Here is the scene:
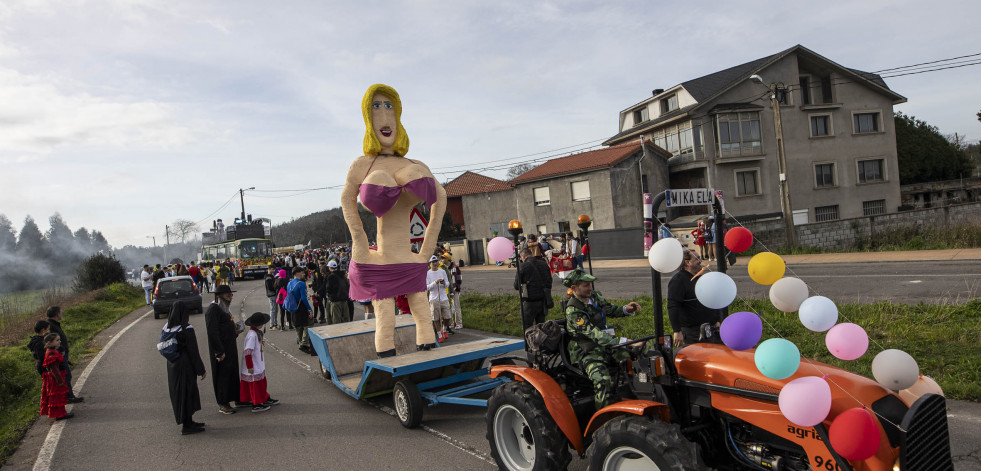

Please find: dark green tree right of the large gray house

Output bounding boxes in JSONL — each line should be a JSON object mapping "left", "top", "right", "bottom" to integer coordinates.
{"left": 895, "top": 113, "right": 972, "bottom": 185}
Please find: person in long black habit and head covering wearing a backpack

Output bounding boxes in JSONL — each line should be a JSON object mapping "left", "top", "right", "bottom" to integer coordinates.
{"left": 164, "top": 301, "right": 207, "bottom": 435}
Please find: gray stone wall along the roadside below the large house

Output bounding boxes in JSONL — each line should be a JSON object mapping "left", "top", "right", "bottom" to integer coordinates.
{"left": 744, "top": 203, "right": 981, "bottom": 250}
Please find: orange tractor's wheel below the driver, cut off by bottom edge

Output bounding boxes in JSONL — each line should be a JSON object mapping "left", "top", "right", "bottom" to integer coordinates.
{"left": 587, "top": 415, "right": 707, "bottom": 471}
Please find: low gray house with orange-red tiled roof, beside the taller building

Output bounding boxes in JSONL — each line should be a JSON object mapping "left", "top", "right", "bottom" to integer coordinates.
{"left": 510, "top": 138, "right": 671, "bottom": 234}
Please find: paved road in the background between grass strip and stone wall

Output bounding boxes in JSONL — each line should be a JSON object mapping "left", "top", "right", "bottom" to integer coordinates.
{"left": 463, "top": 260, "right": 981, "bottom": 304}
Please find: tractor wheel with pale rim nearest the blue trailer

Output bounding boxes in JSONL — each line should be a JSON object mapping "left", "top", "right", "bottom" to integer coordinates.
{"left": 486, "top": 381, "right": 572, "bottom": 471}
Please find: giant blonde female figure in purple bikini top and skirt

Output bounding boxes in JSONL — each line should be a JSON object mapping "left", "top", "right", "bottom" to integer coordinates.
{"left": 341, "top": 84, "right": 446, "bottom": 357}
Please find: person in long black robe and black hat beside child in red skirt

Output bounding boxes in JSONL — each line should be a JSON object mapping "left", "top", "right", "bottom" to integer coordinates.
{"left": 204, "top": 285, "right": 244, "bottom": 414}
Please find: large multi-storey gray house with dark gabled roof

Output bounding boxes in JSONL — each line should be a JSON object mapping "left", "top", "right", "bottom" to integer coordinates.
{"left": 608, "top": 45, "right": 906, "bottom": 227}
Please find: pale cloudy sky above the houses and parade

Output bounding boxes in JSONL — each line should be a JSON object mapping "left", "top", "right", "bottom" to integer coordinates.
{"left": 0, "top": 0, "right": 981, "bottom": 247}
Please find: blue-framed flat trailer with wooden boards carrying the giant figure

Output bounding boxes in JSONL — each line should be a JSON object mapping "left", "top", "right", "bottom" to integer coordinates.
{"left": 309, "top": 315, "right": 524, "bottom": 428}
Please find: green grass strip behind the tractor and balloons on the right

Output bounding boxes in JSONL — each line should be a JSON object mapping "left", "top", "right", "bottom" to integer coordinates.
{"left": 462, "top": 293, "right": 981, "bottom": 402}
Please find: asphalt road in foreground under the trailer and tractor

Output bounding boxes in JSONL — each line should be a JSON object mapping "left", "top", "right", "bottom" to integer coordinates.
{"left": 5, "top": 276, "right": 981, "bottom": 471}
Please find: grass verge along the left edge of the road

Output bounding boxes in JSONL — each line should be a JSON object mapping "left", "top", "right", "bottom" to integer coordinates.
{"left": 0, "top": 283, "right": 145, "bottom": 463}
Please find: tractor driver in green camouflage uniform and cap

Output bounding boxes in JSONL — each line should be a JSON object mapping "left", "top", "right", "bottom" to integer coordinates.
{"left": 562, "top": 268, "right": 640, "bottom": 410}
